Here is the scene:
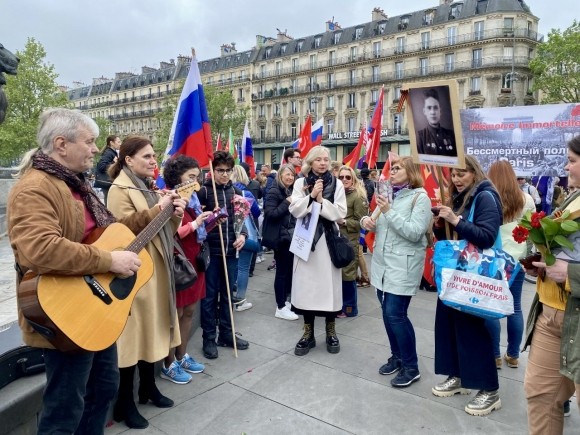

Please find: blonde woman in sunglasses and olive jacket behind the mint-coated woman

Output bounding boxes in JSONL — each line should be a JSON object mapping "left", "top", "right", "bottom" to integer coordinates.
{"left": 337, "top": 166, "right": 369, "bottom": 318}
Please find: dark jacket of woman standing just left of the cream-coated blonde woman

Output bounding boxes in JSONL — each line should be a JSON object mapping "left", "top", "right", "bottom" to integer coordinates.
{"left": 262, "top": 183, "right": 296, "bottom": 249}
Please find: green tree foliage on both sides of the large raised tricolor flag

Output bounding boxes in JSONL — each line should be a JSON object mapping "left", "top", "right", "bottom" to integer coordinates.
{"left": 154, "top": 82, "right": 249, "bottom": 164}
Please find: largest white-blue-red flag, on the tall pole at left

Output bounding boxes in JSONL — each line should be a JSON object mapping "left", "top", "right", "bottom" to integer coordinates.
{"left": 157, "top": 54, "right": 213, "bottom": 187}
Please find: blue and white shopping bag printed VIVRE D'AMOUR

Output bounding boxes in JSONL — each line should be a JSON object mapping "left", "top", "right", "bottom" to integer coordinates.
{"left": 433, "top": 192, "right": 520, "bottom": 319}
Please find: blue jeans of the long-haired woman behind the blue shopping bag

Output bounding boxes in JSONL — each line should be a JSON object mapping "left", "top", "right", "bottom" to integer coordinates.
{"left": 486, "top": 270, "right": 525, "bottom": 358}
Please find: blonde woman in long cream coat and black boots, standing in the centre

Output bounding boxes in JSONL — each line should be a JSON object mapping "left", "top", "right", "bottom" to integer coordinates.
{"left": 290, "top": 146, "right": 346, "bottom": 356}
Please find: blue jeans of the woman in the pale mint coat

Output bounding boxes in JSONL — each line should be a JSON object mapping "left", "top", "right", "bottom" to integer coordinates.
{"left": 377, "top": 289, "right": 419, "bottom": 370}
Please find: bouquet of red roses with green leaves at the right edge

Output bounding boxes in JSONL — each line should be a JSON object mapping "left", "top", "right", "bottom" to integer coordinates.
{"left": 512, "top": 210, "right": 580, "bottom": 266}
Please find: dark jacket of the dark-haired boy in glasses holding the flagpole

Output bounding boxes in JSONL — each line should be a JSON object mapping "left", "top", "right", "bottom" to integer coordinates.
{"left": 197, "top": 180, "right": 247, "bottom": 256}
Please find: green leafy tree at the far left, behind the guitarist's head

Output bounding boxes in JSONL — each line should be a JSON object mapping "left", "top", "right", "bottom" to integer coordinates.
{"left": 0, "top": 38, "right": 69, "bottom": 160}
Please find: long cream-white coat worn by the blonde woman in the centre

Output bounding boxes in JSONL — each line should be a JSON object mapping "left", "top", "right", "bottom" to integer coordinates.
{"left": 290, "top": 178, "right": 346, "bottom": 312}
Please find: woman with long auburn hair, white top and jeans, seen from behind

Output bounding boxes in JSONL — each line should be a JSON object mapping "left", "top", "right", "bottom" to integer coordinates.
{"left": 487, "top": 160, "right": 536, "bottom": 369}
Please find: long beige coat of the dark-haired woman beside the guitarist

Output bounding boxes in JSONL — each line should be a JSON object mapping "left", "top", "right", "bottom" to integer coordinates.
{"left": 107, "top": 172, "right": 180, "bottom": 367}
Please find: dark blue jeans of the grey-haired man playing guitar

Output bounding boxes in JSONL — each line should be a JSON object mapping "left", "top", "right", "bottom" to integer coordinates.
{"left": 38, "top": 344, "right": 119, "bottom": 434}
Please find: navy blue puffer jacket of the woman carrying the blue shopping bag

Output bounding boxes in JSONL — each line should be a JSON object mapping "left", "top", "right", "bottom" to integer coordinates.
{"left": 433, "top": 180, "right": 503, "bottom": 249}
